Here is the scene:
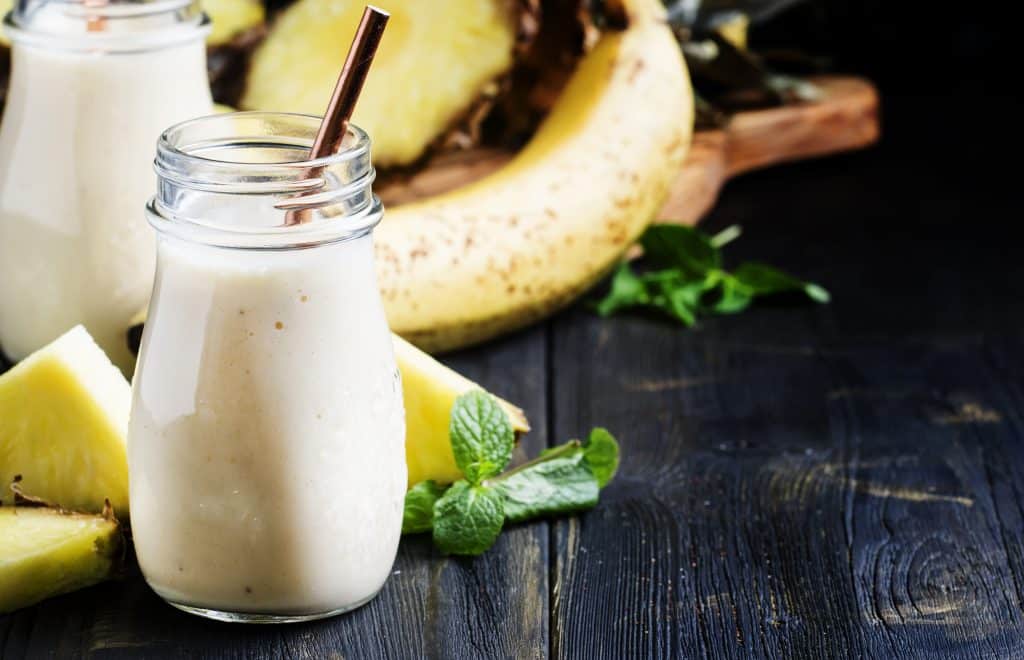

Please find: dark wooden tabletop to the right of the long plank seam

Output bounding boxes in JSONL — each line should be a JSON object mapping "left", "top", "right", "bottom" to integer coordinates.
{"left": 550, "top": 117, "right": 1024, "bottom": 658}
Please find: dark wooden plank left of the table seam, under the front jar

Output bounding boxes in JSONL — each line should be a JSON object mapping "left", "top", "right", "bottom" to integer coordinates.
{"left": 0, "top": 327, "right": 549, "bottom": 660}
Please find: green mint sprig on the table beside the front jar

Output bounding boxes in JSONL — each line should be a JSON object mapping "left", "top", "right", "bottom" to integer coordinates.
{"left": 401, "top": 391, "right": 618, "bottom": 555}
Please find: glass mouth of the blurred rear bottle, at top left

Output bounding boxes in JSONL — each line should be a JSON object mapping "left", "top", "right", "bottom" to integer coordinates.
{"left": 3, "top": 0, "right": 210, "bottom": 53}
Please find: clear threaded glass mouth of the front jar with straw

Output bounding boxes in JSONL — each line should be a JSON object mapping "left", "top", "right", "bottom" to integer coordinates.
{"left": 146, "top": 112, "right": 383, "bottom": 250}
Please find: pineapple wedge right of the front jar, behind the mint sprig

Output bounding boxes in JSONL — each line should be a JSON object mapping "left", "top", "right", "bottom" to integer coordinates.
{"left": 392, "top": 335, "right": 529, "bottom": 486}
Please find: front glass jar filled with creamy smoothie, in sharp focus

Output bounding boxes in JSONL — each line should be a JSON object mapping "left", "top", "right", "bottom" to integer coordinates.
{"left": 128, "top": 113, "right": 407, "bottom": 621}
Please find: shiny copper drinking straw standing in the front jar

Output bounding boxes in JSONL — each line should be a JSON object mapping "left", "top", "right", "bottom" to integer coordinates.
{"left": 285, "top": 5, "right": 390, "bottom": 225}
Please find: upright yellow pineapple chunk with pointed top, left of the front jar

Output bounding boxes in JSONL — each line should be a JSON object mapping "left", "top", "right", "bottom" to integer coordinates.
{"left": 0, "top": 325, "right": 131, "bottom": 516}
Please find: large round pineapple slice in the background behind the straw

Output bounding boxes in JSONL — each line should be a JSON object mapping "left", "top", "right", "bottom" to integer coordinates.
{"left": 242, "top": 0, "right": 520, "bottom": 167}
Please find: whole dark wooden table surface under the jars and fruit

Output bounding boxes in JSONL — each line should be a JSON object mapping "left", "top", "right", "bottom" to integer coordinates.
{"left": 0, "top": 86, "right": 1024, "bottom": 660}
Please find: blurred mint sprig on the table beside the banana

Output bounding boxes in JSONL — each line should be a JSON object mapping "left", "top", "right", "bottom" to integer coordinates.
{"left": 596, "top": 224, "right": 830, "bottom": 326}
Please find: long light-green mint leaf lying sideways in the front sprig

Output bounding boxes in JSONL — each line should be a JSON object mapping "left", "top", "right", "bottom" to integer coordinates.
{"left": 495, "top": 450, "right": 600, "bottom": 523}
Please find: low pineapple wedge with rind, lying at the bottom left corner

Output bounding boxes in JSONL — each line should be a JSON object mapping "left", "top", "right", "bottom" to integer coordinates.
{"left": 0, "top": 507, "right": 121, "bottom": 613}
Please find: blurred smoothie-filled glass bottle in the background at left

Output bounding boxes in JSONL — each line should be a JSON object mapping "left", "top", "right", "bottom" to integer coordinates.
{"left": 0, "top": 0, "right": 212, "bottom": 373}
